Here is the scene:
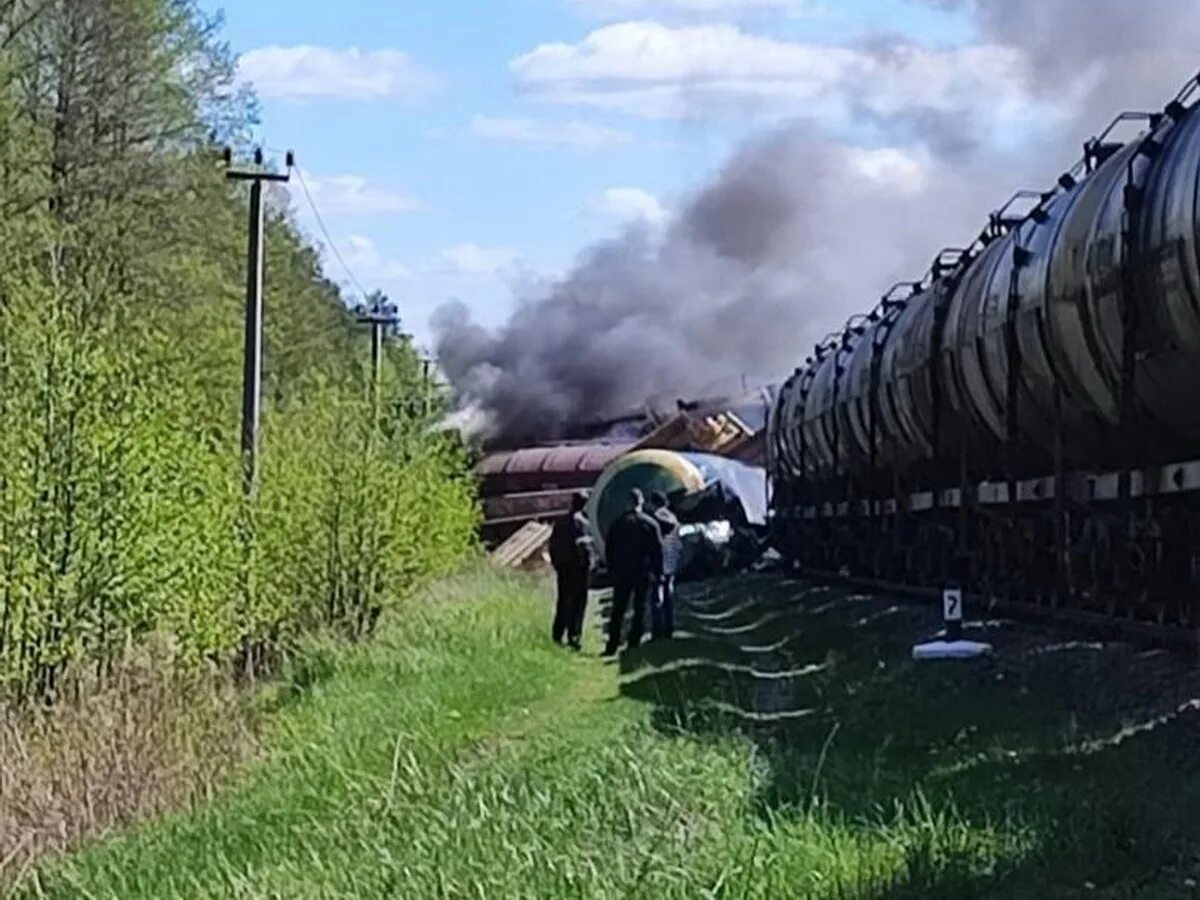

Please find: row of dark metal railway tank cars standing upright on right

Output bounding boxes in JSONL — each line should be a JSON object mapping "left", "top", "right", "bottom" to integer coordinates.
{"left": 767, "top": 79, "right": 1200, "bottom": 628}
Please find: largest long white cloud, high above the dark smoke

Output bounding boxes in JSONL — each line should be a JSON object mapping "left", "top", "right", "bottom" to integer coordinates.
{"left": 509, "top": 22, "right": 1033, "bottom": 120}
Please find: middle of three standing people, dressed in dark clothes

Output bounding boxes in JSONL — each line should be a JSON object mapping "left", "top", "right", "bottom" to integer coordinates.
{"left": 604, "top": 487, "right": 662, "bottom": 656}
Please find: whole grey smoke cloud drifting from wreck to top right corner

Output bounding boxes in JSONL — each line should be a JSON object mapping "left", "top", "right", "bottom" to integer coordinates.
{"left": 433, "top": 0, "right": 1200, "bottom": 444}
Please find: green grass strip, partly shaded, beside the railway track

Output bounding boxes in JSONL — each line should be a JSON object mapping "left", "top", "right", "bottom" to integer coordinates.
{"left": 17, "top": 575, "right": 1200, "bottom": 900}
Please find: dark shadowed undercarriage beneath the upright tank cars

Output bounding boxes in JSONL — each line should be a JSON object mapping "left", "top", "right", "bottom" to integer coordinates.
{"left": 772, "top": 461, "right": 1200, "bottom": 638}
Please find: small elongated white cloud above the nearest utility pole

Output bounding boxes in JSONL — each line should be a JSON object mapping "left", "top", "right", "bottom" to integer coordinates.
{"left": 238, "top": 44, "right": 437, "bottom": 100}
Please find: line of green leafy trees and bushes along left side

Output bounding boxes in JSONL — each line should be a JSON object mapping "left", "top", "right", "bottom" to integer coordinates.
{"left": 0, "top": 0, "right": 476, "bottom": 702}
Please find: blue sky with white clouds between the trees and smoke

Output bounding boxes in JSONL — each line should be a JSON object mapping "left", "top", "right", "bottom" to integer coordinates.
{"left": 203, "top": 0, "right": 995, "bottom": 350}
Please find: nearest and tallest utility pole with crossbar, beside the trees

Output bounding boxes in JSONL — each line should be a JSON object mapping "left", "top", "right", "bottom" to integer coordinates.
{"left": 224, "top": 148, "right": 295, "bottom": 497}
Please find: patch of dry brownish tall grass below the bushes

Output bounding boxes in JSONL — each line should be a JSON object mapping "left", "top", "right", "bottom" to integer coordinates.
{"left": 0, "top": 641, "right": 257, "bottom": 882}
